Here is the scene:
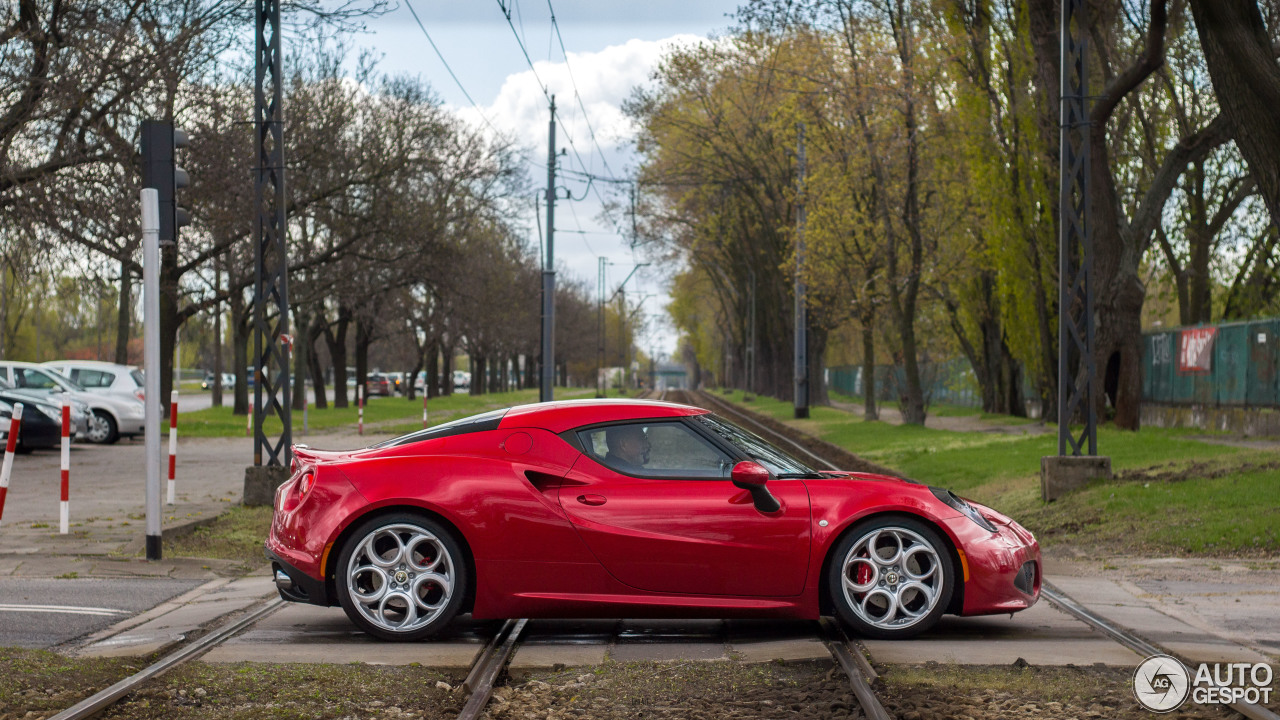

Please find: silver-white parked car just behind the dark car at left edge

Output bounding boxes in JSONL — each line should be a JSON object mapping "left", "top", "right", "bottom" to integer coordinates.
{"left": 0, "top": 360, "right": 124, "bottom": 443}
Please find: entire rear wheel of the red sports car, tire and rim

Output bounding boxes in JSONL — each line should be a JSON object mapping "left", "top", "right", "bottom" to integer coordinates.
{"left": 337, "top": 514, "right": 467, "bottom": 641}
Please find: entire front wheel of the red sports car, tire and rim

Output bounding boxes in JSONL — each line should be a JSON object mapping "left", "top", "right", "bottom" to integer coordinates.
{"left": 827, "top": 518, "right": 955, "bottom": 639}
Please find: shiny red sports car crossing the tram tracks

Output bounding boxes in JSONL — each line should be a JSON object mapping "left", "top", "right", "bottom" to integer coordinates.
{"left": 266, "top": 400, "right": 1041, "bottom": 641}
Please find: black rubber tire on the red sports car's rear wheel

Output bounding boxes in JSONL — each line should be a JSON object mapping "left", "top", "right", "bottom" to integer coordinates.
{"left": 334, "top": 512, "right": 471, "bottom": 642}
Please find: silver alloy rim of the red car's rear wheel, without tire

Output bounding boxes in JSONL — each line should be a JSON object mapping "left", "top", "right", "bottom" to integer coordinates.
{"left": 346, "top": 523, "right": 456, "bottom": 633}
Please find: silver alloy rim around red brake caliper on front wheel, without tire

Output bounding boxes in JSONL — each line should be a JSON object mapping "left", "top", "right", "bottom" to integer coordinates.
{"left": 840, "top": 527, "right": 946, "bottom": 630}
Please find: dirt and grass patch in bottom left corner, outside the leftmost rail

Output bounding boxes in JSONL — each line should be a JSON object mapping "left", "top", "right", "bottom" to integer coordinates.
{"left": 0, "top": 647, "right": 141, "bottom": 720}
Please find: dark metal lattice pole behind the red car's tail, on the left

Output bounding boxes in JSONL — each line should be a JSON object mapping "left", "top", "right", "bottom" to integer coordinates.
{"left": 253, "top": 0, "right": 292, "bottom": 466}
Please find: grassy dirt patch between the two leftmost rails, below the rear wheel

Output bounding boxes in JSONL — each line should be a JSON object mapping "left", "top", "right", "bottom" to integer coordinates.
{"left": 102, "top": 662, "right": 466, "bottom": 720}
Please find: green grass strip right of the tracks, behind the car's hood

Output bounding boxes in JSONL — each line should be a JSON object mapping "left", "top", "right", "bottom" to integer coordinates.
{"left": 727, "top": 393, "right": 1280, "bottom": 555}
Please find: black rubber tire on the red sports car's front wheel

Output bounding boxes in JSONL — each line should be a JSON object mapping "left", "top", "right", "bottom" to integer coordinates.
{"left": 827, "top": 515, "right": 956, "bottom": 639}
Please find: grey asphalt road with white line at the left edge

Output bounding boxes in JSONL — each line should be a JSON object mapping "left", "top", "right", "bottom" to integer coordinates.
{"left": 0, "top": 577, "right": 202, "bottom": 647}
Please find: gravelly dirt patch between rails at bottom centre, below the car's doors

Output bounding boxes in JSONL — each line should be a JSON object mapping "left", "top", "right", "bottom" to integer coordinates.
{"left": 489, "top": 661, "right": 863, "bottom": 720}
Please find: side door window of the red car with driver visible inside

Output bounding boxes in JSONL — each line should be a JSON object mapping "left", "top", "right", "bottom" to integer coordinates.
{"left": 579, "top": 421, "right": 733, "bottom": 479}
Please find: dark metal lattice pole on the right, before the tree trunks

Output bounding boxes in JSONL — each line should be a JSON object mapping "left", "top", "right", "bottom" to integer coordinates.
{"left": 1057, "top": 0, "right": 1098, "bottom": 455}
